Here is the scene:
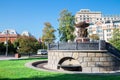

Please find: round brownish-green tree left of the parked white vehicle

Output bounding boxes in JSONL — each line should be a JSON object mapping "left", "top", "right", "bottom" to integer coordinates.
{"left": 14, "top": 36, "right": 39, "bottom": 54}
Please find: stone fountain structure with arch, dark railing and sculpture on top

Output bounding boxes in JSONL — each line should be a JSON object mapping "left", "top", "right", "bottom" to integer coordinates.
{"left": 29, "top": 22, "right": 120, "bottom": 73}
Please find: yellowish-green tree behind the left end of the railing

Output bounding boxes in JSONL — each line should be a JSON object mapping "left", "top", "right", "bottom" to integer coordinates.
{"left": 42, "top": 22, "right": 55, "bottom": 43}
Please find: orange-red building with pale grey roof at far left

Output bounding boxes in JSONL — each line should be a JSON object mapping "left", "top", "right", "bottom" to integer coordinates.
{"left": 0, "top": 29, "right": 18, "bottom": 43}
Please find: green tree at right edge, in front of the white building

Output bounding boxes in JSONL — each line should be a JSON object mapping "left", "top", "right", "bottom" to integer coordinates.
{"left": 109, "top": 28, "right": 120, "bottom": 50}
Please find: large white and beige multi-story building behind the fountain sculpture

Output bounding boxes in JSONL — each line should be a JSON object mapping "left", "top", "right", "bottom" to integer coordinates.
{"left": 75, "top": 9, "right": 120, "bottom": 41}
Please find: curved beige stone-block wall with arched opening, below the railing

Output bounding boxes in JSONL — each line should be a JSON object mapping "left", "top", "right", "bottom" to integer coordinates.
{"left": 48, "top": 50, "right": 120, "bottom": 73}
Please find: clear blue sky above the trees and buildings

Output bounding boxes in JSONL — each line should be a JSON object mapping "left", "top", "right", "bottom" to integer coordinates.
{"left": 0, "top": 0, "right": 120, "bottom": 39}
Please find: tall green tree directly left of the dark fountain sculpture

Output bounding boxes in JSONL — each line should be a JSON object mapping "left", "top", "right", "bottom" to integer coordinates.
{"left": 58, "top": 9, "right": 75, "bottom": 42}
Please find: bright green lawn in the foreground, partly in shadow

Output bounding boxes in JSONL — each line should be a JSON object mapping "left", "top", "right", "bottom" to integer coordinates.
{"left": 0, "top": 58, "right": 120, "bottom": 80}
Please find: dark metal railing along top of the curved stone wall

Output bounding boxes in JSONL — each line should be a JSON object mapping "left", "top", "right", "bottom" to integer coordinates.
{"left": 48, "top": 40, "right": 106, "bottom": 50}
